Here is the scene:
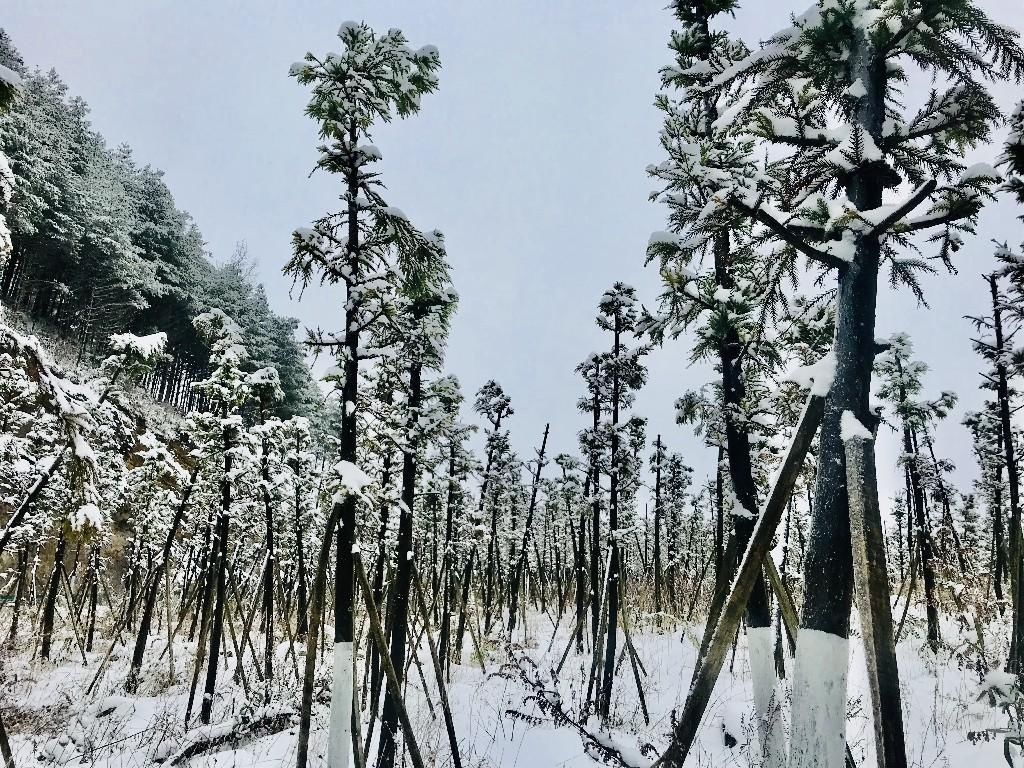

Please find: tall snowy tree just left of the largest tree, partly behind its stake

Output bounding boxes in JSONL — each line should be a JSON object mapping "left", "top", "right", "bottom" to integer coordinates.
{"left": 648, "top": 2, "right": 792, "bottom": 766}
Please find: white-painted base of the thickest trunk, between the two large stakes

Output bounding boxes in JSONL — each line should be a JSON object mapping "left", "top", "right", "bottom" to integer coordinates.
{"left": 790, "top": 629, "right": 850, "bottom": 768}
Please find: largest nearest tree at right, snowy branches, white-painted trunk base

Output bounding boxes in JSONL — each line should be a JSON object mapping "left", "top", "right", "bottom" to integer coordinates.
{"left": 719, "top": 0, "right": 1024, "bottom": 768}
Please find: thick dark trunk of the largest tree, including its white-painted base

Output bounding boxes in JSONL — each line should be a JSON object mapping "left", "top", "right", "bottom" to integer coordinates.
{"left": 790, "top": 30, "right": 887, "bottom": 768}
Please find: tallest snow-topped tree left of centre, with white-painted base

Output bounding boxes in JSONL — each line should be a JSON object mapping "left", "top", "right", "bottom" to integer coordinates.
{"left": 285, "top": 22, "right": 440, "bottom": 768}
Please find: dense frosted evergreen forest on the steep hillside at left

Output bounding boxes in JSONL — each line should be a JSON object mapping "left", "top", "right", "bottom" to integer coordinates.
{"left": 0, "top": 30, "right": 319, "bottom": 415}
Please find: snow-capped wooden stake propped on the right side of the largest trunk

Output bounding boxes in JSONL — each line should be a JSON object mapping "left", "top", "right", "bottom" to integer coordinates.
{"left": 843, "top": 428, "right": 906, "bottom": 768}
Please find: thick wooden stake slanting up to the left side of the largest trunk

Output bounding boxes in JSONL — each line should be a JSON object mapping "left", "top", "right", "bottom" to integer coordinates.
{"left": 655, "top": 394, "right": 824, "bottom": 768}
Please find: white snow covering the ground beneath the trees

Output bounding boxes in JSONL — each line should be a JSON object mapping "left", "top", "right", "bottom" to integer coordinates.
{"left": 0, "top": 615, "right": 1006, "bottom": 768}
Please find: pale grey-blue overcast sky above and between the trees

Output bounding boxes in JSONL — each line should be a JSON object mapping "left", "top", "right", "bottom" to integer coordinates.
{"left": 0, "top": 0, "right": 1024, "bottom": 507}
